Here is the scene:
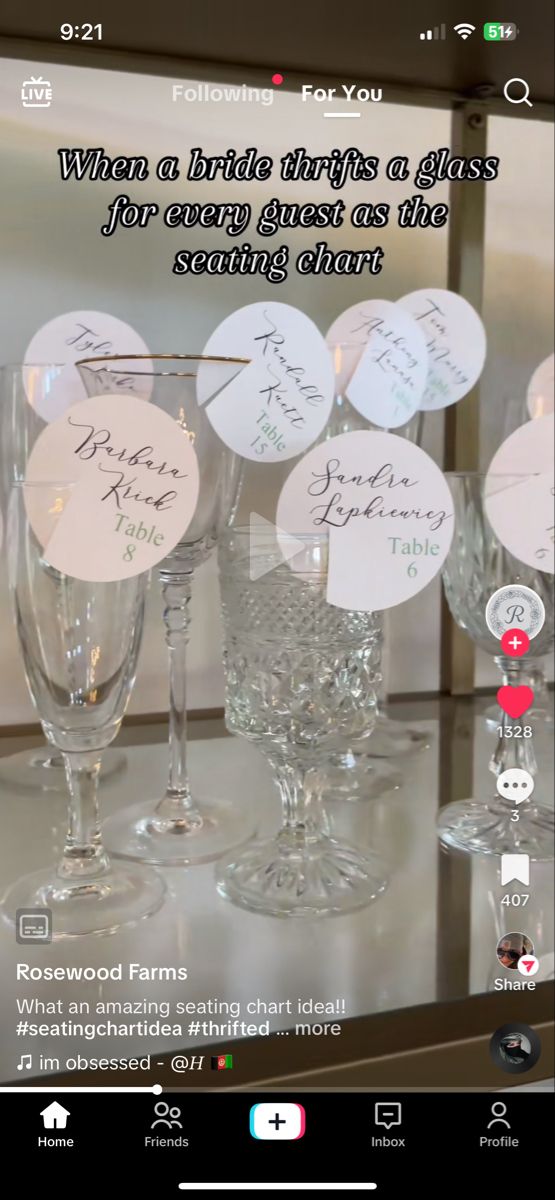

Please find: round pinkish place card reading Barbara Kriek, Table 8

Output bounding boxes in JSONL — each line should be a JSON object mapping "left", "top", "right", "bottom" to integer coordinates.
{"left": 25, "top": 394, "right": 198, "bottom": 582}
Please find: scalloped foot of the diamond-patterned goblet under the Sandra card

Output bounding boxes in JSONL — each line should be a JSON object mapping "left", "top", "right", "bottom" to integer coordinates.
{"left": 216, "top": 833, "right": 388, "bottom": 917}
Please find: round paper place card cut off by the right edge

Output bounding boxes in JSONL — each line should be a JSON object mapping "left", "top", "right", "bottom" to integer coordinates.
{"left": 485, "top": 413, "right": 555, "bottom": 574}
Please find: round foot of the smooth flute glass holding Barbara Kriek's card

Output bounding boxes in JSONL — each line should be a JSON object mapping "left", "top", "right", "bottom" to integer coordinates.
{"left": 2, "top": 863, "right": 166, "bottom": 941}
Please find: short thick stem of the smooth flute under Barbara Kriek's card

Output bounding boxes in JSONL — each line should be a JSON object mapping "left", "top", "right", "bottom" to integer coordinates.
{"left": 58, "top": 750, "right": 109, "bottom": 880}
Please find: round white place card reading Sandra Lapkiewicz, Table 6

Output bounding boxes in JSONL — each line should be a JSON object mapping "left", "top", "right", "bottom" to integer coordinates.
{"left": 276, "top": 430, "right": 454, "bottom": 611}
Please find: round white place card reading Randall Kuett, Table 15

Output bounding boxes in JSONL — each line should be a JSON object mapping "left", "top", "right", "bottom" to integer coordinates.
{"left": 197, "top": 301, "right": 334, "bottom": 462}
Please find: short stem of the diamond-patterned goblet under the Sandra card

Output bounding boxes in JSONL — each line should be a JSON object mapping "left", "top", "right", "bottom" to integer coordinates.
{"left": 268, "top": 755, "right": 329, "bottom": 852}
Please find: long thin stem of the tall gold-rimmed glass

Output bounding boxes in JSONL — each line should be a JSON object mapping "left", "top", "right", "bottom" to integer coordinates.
{"left": 156, "top": 571, "right": 201, "bottom": 822}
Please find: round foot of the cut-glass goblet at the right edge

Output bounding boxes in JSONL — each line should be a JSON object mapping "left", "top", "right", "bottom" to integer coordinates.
{"left": 437, "top": 800, "right": 555, "bottom": 860}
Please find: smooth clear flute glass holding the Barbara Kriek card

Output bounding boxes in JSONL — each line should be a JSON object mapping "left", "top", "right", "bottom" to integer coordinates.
{"left": 2, "top": 484, "right": 165, "bottom": 938}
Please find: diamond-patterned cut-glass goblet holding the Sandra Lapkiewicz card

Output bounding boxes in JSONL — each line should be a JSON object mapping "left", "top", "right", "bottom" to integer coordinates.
{"left": 216, "top": 528, "right": 387, "bottom": 917}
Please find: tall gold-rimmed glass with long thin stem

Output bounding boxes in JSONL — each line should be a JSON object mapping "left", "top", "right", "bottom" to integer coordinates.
{"left": 77, "top": 354, "right": 252, "bottom": 866}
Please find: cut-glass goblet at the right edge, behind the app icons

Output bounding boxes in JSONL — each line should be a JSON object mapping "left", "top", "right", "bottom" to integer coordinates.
{"left": 438, "top": 473, "right": 554, "bottom": 859}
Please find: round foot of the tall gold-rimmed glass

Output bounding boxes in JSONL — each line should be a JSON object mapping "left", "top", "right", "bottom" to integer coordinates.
{"left": 102, "top": 800, "right": 255, "bottom": 866}
